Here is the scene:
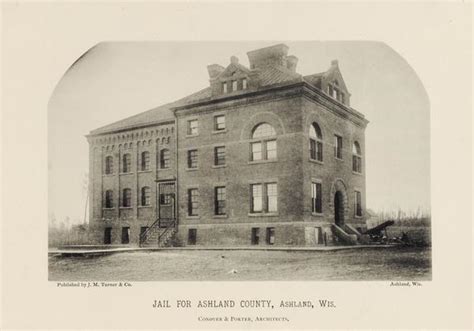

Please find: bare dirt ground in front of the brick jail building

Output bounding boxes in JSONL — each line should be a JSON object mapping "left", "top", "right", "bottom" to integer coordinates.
{"left": 49, "top": 247, "right": 431, "bottom": 281}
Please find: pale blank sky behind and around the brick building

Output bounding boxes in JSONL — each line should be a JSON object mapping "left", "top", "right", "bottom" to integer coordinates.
{"left": 48, "top": 41, "right": 430, "bottom": 222}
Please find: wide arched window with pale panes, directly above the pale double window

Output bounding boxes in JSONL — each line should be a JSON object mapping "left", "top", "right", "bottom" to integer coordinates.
{"left": 250, "top": 123, "right": 277, "bottom": 161}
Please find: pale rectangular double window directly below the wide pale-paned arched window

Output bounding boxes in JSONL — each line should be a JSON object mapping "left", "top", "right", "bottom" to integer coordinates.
{"left": 250, "top": 183, "right": 278, "bottom": 213}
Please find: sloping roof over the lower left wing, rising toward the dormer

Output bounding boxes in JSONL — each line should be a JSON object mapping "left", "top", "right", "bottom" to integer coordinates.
{"left": 90, "top": 87, "right": 211, "bottom": 135}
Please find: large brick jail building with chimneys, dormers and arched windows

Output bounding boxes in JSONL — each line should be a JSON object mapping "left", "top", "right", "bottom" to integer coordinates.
{"left": 87, "top": 44, "right": 368, "bottom": 246}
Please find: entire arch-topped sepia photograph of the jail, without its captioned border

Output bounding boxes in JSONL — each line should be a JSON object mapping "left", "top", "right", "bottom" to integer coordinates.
{"left": 48, "top": 41, "right": 432, "bottom": 285}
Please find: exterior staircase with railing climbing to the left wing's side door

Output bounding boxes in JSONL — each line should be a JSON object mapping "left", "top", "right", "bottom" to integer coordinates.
{"left": 139, "top": 219, "right": 177, "bottom": 247}
